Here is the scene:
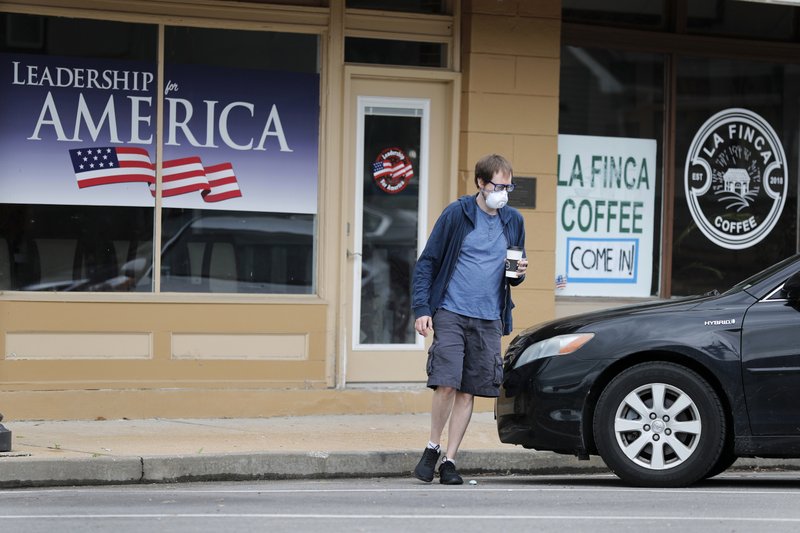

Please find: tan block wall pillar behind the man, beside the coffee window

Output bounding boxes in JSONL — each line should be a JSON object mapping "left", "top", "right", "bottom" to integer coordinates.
{"left": 458, "top": 0, "right": 561, "bottom": 343}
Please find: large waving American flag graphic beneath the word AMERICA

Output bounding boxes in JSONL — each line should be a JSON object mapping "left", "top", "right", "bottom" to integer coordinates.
{"left": 69, "top": 146, "right": 242, "bottom": 202}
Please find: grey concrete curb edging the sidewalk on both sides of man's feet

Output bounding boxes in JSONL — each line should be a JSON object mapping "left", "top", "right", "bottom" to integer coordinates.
{"left": 0, "top": 450, "right": 608, "bottom": 488}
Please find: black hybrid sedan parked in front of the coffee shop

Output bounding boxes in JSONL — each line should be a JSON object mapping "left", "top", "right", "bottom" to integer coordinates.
{"left": 496, "top": 255, "right": 800, "bottom": 487}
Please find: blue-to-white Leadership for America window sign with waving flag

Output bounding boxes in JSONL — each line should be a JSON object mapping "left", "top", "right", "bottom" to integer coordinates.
{"left": 0, "top": 54, "right": 319, "bottom": 213}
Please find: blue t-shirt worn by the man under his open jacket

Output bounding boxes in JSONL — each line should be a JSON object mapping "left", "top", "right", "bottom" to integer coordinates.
{"left": 442, "top": 208, "right": 508, "bottom": 320}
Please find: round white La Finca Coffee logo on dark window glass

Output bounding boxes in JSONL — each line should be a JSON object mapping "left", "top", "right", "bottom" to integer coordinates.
{"left": 685, "top": 109, "right": 788, "bottom": 250}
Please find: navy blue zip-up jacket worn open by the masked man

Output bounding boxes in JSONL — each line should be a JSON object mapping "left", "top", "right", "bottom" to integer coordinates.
{"left": 411, "top": 195, "right": 525, "bottom": 335}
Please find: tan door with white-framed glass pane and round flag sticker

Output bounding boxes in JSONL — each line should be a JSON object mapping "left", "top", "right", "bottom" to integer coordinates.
{"left": 344, "top": 74, "right": 455, "bottom": 383}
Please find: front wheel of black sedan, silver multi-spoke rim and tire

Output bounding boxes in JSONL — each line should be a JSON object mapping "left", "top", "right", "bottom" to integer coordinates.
{"left": 593, "top": 362, "right": 726, "bottom": 487}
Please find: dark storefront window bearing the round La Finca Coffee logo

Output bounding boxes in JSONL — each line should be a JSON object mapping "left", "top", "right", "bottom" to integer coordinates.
{"left": 672, "top": 57, "right": 800, "bottom": 295}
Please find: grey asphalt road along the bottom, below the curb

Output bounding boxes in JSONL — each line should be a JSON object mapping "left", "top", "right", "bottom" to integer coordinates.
{"left": 0, "top": 472, "right": 800, "bottom": 533}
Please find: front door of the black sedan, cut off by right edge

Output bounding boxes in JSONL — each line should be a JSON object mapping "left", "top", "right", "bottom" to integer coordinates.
{"left": 742, "top": 288, "right": 800, "bottom": 435}
